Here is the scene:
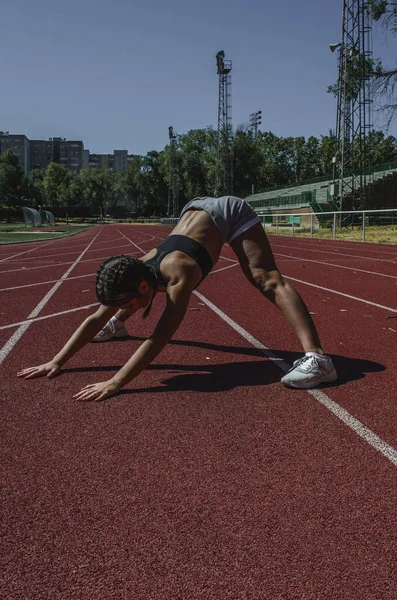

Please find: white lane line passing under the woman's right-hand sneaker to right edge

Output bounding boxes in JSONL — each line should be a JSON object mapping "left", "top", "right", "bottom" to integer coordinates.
{"left": 193, "top": 291, "right": 397, "bottom": 466}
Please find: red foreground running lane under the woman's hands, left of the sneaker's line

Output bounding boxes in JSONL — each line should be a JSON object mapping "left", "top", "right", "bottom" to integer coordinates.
{"left": 0, "top": 290, "right": 397, "bottom": 600}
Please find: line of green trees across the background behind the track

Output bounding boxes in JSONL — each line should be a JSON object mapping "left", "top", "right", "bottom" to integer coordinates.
{"left": 0, "top": 126, "right": 397, "bottom": 218}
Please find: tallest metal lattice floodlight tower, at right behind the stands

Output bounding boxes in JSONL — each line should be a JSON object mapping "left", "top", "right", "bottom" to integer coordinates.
{"left": 330, "top": 0, "right": 372, "bottom": 210}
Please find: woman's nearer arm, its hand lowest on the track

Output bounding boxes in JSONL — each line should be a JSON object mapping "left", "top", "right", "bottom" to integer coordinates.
{"left": 74, "top": 282, "right": 192, "bottom": 401}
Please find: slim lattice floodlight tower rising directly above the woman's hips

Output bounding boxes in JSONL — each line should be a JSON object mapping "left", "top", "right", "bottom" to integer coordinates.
{"left": 215, "top": 50, "right": 233, "bottom": 197}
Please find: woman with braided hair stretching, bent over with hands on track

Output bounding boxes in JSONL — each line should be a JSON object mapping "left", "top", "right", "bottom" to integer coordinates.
{"left": 18, "top": 196, "right": 337, "bottom": 401}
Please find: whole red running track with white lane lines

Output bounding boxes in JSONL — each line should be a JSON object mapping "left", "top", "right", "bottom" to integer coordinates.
{"left": 0, "top": 226, "right": 397, "bottom": 600}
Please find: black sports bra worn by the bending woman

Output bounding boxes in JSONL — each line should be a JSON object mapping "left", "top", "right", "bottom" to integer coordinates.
{"left": 145, "top": 235, "right": 213, "bottom": 287}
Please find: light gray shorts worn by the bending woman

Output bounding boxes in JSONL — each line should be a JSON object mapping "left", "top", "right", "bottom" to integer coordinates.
{"left": 181, "top": 196, "right": 260, "bottom": 244}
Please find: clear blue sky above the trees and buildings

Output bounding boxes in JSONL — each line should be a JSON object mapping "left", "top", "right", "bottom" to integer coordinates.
{"left": 0, "top": 0, "right": 397, "bottom": 154}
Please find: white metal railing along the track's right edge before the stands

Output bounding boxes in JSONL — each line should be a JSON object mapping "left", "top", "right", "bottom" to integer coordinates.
{"left": 257, "top": 208, "right": 397, "bottom": 243}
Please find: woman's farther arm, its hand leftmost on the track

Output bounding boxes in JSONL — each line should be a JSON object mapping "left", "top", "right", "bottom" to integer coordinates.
{"left": 17, "top": 305, "right": 118, "bottom": 379}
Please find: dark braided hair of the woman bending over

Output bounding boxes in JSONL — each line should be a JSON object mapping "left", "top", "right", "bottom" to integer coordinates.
{"left": 96, "top": 254, "right": 157, "bottom": 319}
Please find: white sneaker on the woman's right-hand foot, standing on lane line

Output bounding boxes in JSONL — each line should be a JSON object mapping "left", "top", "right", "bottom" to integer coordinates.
{"left": 281, "top": 354, "right": 338, "bottom": 389}
